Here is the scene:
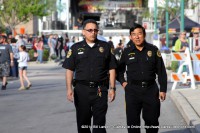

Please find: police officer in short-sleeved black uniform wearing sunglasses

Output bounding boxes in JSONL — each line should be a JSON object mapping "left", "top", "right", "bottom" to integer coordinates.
{"left": 63, "top": 19, "right": 116, "bottom": 133}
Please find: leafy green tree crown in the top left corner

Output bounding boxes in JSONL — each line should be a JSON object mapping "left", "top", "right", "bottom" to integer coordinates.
{"left": 0, "top": 0, "right": 56, "bottom": 32}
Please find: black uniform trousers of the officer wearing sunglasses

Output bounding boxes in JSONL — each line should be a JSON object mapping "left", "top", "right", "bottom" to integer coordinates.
{"left": 74, "top": 83, "right": 108, "bottom": 133}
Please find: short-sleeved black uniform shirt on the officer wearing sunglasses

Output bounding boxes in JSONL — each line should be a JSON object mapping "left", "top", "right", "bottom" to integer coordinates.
{"left": 63, "top": 40, "right": 117, "bottom": 82}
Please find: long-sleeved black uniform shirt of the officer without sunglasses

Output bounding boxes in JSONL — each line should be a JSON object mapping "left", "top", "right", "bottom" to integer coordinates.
{"left": 118, "top": 42, "right": 167, "bottom": 92}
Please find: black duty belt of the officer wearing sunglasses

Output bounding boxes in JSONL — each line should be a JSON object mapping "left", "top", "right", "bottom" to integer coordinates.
{"left": 75, "top": 80, "right": 108, "bottom": 88}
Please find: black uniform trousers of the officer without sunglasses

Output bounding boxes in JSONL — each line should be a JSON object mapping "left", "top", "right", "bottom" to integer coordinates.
{"left": 125, "top": 82, "right": 160, "bottom": 133}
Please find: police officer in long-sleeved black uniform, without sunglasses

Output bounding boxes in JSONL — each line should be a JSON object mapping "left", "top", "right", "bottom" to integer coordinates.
{"left": 117, "top": 24, "right": 167, "bottom": 133}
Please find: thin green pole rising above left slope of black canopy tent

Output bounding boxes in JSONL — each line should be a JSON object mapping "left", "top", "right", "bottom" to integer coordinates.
{"left": 165, "top": 0, "right": 169, "bottom": 47}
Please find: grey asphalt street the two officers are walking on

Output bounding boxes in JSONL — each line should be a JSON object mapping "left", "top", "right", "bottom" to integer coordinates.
{"left": 0, "top": 62, "right": 199, "bottom": 133}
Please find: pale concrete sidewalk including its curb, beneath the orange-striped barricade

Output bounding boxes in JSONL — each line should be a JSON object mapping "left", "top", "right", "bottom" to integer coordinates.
{"left": 171, "top": 89, "right": 200, "bottom": 133}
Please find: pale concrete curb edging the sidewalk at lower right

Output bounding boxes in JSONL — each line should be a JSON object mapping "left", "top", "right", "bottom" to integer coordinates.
{"left": 170, "top": 89, "right": 200, "bottom": 133}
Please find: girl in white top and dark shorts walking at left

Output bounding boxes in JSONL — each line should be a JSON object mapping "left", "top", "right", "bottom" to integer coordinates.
{"left": 18, "top": 45, "right": 31, "bottom": 90}
